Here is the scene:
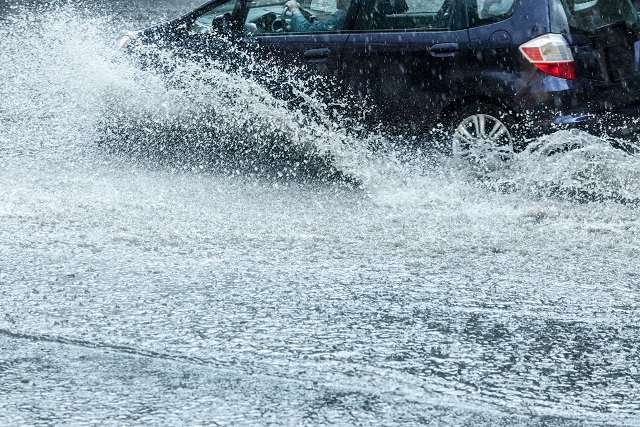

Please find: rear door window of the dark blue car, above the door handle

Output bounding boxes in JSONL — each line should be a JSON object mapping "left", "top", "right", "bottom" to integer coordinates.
{"left": 369, "top": 0, "right": 453, "bottom": 30}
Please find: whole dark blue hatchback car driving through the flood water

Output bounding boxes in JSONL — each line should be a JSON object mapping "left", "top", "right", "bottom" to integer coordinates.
{"left": 122, "top": 0, "right": 640, "bottom": 157}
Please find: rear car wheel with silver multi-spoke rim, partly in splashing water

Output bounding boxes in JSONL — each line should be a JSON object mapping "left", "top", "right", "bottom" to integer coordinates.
{"left": 445, "top": 104, "right": 516, "bottom": 167}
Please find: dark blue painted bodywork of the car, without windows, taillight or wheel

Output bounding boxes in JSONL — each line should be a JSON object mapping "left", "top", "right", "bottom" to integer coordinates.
{"left": 124, "top": 0, "right": 640, "bottom": 142}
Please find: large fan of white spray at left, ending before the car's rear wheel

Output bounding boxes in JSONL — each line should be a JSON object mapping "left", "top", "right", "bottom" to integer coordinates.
{"left": 0, "top": 2, "right": 400, "bottom": 181}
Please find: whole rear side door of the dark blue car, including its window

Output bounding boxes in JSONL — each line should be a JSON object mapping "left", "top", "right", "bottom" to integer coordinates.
{"left": 344, "top": 0, "right": 469, "bottom": 127}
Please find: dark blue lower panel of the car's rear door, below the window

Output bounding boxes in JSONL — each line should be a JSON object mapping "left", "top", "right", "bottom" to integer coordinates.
{"left": 344, "top": 30, "right": 468, "bottom": 122}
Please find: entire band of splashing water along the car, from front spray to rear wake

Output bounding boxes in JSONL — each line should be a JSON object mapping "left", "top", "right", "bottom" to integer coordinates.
{"left": 0, "top": 1, "right": 640, "bottom": 203}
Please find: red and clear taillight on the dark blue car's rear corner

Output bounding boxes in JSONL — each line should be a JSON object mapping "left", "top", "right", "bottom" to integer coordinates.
{"left": 520, "top": 34, "right": 578, "bottom": 80}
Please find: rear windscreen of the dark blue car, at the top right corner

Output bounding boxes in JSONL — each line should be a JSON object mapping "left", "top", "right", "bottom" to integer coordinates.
{"left": 562, "top": 0, "right": 638, "bottom": 34}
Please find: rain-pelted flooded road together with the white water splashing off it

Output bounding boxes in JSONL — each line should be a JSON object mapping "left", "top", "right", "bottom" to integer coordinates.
{"left": 0, "top": 1, "right": 640, "bottom": 426}
